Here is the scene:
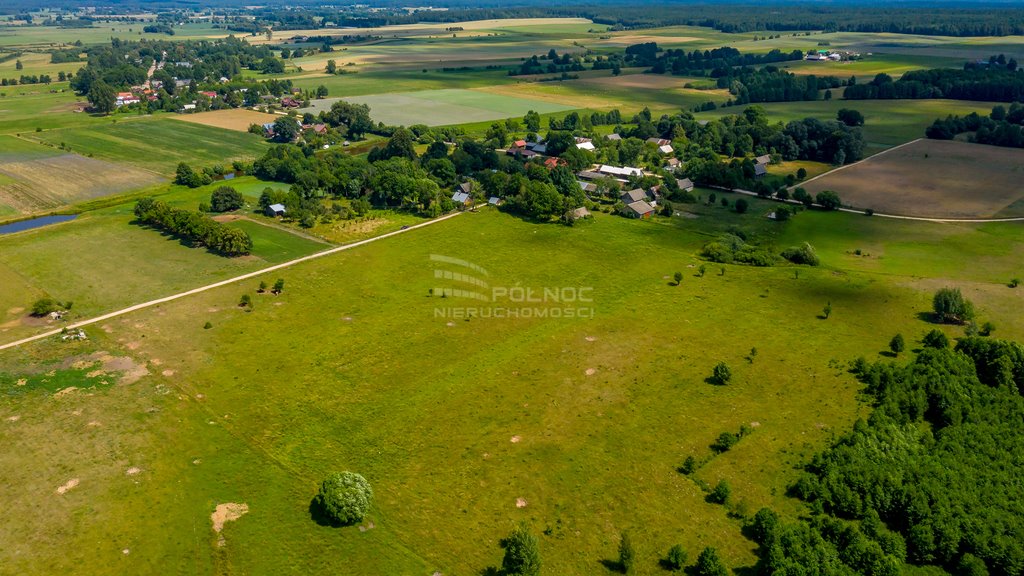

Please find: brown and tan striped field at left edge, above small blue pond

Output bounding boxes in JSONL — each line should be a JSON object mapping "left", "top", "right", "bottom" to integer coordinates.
{"left": 0, "top": 154, "right": 163, "bottom": 212}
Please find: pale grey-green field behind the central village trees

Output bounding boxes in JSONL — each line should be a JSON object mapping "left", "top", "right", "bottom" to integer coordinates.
{"left": 304, "top": 89, "right": 573, "bottom": 126}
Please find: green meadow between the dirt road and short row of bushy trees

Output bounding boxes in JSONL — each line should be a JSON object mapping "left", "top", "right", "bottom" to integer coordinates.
{"left": 0, "top": 182, "right": 327, "bottom": 341}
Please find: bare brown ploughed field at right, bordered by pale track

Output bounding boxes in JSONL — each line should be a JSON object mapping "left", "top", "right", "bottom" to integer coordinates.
{"left": 803, "top": 139, "right": 1024, "bottom": 218}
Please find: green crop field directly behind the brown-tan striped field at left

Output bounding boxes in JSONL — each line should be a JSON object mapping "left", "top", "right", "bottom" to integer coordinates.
{"left": 29, "top": 116, "right": 270, "bottom": 175}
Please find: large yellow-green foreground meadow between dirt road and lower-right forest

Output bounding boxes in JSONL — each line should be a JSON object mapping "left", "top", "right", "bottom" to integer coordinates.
{"left": 0, "top": 203, "right": 1024, "bottom": 574}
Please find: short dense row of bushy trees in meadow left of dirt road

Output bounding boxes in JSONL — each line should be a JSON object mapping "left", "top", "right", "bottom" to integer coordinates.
{"left": 134, "top": 198, "right": 253, "bottom": 256}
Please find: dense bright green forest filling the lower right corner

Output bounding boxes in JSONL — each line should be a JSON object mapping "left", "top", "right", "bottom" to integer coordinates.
{"left": 751, "top": 336, "right": 1024, "bottom": 576}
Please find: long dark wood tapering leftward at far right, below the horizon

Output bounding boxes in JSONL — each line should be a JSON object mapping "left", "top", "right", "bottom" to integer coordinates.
{"left": 844, "top": 54, "right": 1024, "bottom": 102}
